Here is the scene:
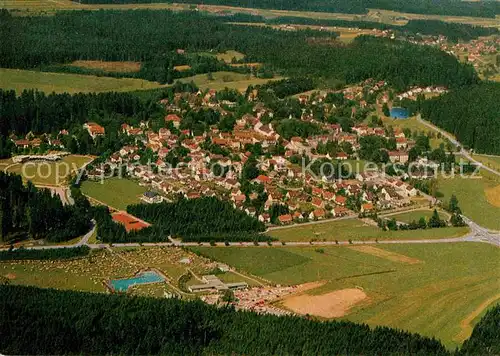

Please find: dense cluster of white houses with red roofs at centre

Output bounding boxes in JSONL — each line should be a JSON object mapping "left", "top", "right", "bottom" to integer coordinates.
{"left": 80, "top": 82, "right": 424, "bottom": 224}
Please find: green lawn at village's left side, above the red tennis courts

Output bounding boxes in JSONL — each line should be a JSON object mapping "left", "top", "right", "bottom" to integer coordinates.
{"left": 81, "top": 177, "right": 147, "bottom": 210}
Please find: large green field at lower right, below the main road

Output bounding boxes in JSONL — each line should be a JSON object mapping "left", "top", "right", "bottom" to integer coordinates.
{"left": 193, "top": 243, "right": 500, "bottom": 347}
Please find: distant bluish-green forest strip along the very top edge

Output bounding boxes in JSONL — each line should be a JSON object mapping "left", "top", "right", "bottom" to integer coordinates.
{"left": 73, "top": 0, "right": 500, "bottom": 18}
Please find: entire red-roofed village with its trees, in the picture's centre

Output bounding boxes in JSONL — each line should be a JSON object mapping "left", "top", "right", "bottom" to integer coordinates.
{"left": 50, "top": 80, "right": 445, "bottom": 225}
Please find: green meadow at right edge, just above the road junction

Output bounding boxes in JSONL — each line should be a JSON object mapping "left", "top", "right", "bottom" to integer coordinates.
{"left": 438, "top": 177, "right": 500, "bottom": 230}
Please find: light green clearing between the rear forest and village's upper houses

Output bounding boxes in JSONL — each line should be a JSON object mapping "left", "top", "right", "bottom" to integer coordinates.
{"left": 178, "top": 72, "right": 283, "bottom": 92}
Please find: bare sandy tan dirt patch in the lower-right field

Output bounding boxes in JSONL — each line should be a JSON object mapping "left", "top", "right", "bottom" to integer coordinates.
{"left": 283, "top": 288, "right": 367, "bottom": 318}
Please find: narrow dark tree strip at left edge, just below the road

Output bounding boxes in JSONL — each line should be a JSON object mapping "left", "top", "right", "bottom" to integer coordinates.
{"left": 0, "top": 245, "right": 90, "bottom": 261}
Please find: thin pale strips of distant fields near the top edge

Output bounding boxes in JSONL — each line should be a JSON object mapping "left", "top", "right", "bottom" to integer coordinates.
{"left": 4, "top": 0, "right": 500, "bottom": 27}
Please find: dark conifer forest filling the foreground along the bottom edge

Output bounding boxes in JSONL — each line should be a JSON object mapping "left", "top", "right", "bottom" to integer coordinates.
{"left": 0, "top": 285, "right": 449, "bottom": 355}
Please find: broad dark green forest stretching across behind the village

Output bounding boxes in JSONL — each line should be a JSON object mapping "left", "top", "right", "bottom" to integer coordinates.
{"left": 0, "top": 10, "right": 478, "bottom": 90}
